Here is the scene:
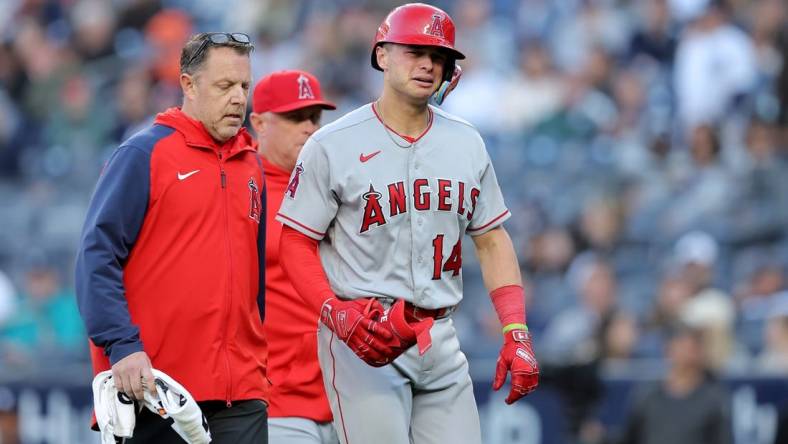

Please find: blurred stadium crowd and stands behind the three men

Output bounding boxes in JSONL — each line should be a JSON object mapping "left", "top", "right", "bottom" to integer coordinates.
{"left": 0, "top": 0, "right": 788, "bottom": 444}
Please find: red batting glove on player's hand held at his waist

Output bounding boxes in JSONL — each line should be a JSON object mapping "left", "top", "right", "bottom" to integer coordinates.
{"left": 320, "top": 298, "right": 393, "bottom": 367}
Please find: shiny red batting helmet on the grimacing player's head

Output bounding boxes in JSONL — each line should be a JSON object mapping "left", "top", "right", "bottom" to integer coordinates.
{"left": 372, "top": 3, "right": 465, "bottom": 78}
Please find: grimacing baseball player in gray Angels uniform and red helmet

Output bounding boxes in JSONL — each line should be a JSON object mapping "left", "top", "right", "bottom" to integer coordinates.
{"left": 277, "top": 4, "right": 539, "bottom": 444}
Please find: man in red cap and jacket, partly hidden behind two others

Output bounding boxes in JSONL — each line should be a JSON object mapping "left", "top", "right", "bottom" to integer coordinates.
{"left": 249, "top": 67, "right": 338, "bottom": 444}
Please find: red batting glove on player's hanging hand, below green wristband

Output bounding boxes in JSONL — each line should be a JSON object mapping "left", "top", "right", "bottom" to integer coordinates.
{"left": 493, "top": 324, "right": 539, "bottom": 404}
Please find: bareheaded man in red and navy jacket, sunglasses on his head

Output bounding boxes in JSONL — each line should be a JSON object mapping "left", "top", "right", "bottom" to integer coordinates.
{"left": 76, "top": 33, "right": 268, "bottom": 444}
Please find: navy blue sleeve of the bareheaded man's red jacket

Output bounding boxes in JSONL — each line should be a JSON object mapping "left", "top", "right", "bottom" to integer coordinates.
{"left": 75, "top": 145, "right": 152, "bottom": 365}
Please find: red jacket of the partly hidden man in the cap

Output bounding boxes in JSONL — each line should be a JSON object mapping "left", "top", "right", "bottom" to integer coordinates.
{"left": 262, "top": 157, "right": 332, "bottom": 422}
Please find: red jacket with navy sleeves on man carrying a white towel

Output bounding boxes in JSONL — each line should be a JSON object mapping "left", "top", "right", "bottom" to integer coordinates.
{"left": 76, "top": 108, "right": 268, "bottom": 402}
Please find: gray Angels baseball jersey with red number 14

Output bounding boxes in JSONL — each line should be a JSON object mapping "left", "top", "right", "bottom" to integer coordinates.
{"left": 277, "top": 104, "right": 510, "bottom": 308}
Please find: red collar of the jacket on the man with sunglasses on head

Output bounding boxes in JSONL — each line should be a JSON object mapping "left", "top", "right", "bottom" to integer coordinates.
{"left": 155, "top": 107, "right": 255, "bottom": 157}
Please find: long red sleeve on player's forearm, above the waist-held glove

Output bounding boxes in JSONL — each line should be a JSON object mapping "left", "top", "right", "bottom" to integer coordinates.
{"left": 279, "top": 225, "right": 334, "bottom": 313}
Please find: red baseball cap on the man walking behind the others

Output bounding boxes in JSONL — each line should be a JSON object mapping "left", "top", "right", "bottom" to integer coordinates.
{"left": 252, "top": 70, "right": 337, "bottom": 113}
